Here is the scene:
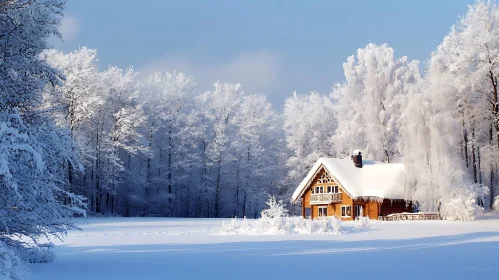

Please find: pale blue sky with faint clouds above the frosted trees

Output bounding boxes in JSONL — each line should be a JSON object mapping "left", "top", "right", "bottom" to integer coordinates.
{"left": 53, "top": 0, "right": 474, "bottom": 110}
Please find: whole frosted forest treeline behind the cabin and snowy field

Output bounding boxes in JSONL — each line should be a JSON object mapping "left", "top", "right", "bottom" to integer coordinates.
{"left": 49, "top": 2, "right": 499, "bottom": 219}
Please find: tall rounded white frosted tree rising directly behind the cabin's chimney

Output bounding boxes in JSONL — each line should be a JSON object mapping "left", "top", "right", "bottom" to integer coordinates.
{"left": 332, "top": 44, "right": 420, "bottom": 162}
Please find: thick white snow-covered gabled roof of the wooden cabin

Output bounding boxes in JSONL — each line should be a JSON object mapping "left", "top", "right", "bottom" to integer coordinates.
{"left": 292, "top": 158, "right": 404, "bottom": 203}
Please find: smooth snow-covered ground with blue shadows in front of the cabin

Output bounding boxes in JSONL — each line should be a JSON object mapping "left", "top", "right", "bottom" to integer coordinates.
{"left": 31, "top": 216, "right": 499, "bottom": 280}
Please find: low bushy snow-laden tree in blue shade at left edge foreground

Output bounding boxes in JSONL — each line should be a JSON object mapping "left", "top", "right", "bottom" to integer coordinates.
{"left": 0, "top": 110, "right": 84, "bottom": 254}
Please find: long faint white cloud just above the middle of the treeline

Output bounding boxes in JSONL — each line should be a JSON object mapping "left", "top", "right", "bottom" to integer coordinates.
{"left": 139, "top": 50, "right": 282, "bottom": 94}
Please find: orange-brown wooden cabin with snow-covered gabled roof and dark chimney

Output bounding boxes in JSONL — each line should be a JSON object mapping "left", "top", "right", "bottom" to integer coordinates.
{"left": 292, "top": 151, "right": 413, "bottom": 220}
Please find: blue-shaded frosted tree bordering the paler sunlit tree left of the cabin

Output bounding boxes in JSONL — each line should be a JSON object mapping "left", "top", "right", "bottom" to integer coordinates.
{"left": 234, "top": 94, "right": 286, "bottom": 217}
